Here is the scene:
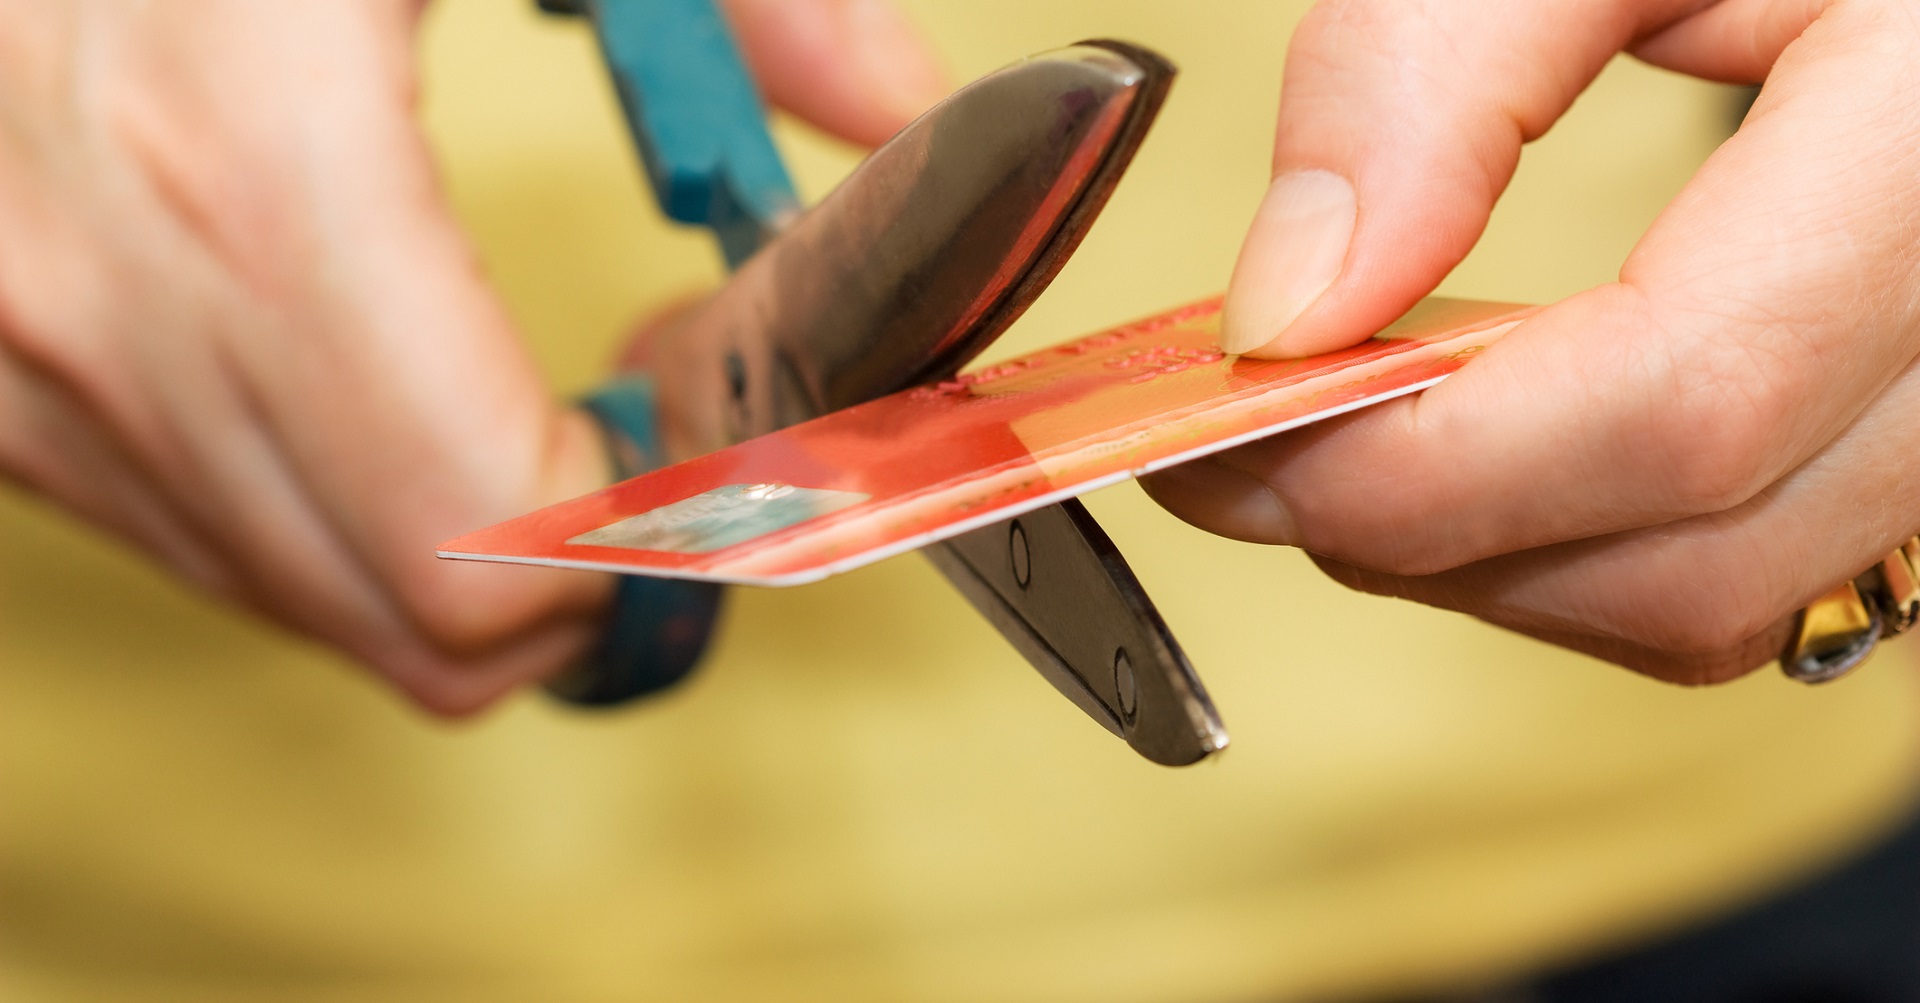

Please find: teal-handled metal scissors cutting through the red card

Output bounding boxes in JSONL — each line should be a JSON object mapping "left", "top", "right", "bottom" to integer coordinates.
{"left": 538, "top": 0, "right": 1227, "bottom": 765}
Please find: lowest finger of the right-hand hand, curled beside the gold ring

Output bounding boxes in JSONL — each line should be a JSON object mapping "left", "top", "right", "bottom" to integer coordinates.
{"left": 1321, "top": 353, "right": 1920, "bottom": 682}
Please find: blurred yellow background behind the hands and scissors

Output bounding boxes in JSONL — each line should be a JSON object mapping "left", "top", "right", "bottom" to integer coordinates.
{"left": 0, "top": 0, "right": 1920, "bottom": 1001}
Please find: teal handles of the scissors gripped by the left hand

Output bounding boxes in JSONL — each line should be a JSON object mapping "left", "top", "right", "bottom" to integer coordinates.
{"left": 538, "top": 0, "right": 799, "bottom": 707}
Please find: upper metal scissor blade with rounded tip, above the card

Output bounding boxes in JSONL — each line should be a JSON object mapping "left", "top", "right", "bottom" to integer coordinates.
{"left": 651, "top": 42, "right": 1173, "bottom": 459}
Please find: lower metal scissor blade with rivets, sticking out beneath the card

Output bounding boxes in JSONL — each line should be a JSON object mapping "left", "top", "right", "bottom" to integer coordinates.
{"left": 924, "top": 500, "right": 1227, "bottom": 767}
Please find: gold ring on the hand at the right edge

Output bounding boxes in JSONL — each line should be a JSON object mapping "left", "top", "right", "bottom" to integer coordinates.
{"left": 1780, "top": 536, "right": 1920, "bottom": 682}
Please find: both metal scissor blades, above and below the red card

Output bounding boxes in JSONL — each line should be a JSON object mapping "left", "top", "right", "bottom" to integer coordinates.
{"left": 651, "top": 42, "right": 1227, "bottom": 765}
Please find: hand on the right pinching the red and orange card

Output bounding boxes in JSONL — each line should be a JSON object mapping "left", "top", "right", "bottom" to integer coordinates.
{"left": 1148, "top": 0, "right": 1920, "bottom": 682}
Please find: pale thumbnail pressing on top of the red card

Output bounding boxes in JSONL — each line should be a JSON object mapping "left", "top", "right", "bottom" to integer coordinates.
{"left": 1219, "top": 171, "right": 1356, "bottom": 355}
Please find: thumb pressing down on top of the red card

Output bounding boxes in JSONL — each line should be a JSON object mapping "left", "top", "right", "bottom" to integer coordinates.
{"left": 1221, "top": 0, "right": 1699, "bottom": 357}
